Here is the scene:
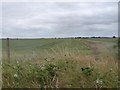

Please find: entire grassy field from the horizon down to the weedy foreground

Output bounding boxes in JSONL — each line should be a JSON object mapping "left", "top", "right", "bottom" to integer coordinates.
{"left": 2, "top": 38, "right": 118, "bottom": 88}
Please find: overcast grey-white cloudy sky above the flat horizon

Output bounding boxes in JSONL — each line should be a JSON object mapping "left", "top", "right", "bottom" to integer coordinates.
{"left": 0, "top": 2, "right": 118, "bottom": 38}
